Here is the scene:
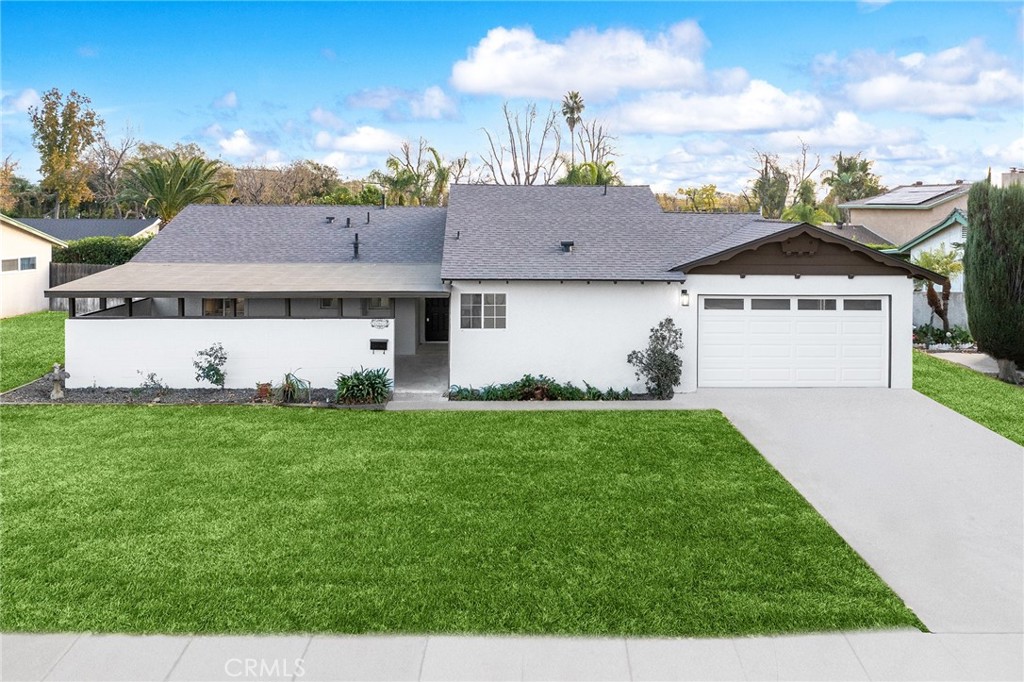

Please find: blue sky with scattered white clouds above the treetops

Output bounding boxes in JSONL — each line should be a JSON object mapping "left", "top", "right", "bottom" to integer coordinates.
{"left": 0, "top": 0, "right": 1024, "bottom": 191}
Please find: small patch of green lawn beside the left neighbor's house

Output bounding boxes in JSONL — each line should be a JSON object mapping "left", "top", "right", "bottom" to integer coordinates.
{"left": 0, "top": 312, "right": 68, "bottom": 391}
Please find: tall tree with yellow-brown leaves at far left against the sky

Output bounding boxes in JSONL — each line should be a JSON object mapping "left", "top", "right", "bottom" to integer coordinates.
{"left": 29, "top": 88, "right": 103, "bottom": 218}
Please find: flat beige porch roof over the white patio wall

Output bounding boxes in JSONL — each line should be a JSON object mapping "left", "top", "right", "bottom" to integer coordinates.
{"left": 46, "top": 262, "right": 446, "bottom": 298}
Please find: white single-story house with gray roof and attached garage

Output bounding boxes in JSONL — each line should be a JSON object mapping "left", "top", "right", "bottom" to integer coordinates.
{"left": 47, "top": 185, "right": 941, "bottom": 391}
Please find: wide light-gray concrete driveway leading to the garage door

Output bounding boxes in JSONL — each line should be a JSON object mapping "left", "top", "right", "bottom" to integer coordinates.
{"left": 696, "top": 389, "right": 1024, "bottom": 633}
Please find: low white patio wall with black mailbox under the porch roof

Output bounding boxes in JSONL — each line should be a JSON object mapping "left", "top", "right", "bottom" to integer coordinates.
{"left": 65, "top": 317, "right": 394, "bottom": 388}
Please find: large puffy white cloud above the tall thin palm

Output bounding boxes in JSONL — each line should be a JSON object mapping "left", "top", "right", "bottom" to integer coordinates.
{"left": 452, "top": 22, "right": 709, "bottom": 100}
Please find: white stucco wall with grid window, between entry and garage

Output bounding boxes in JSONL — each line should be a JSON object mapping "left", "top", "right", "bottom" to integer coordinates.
{"left": 449, "top": 281, "right": 680, "bottom": 391}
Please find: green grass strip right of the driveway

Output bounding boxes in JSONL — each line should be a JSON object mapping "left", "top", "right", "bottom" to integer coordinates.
{"left": 913, "top": 350, "right": 1024, "bottom": 445}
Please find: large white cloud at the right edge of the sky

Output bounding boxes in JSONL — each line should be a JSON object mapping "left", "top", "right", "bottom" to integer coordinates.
{"left": 827, "top": 39, "right": 1024, "bottom": 118}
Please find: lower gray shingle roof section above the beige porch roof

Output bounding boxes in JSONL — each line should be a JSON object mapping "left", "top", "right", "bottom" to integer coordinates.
{"left": 132, "top": 201, "right": 445, "bottom": 263}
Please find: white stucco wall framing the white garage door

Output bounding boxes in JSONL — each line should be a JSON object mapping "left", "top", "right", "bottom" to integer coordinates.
{"left": 676, "top": 274, "right": 913, "bottom": 392}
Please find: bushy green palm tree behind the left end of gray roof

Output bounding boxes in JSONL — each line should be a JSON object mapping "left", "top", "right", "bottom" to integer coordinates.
{"left": 129, "top": 153, "right": 231, "bottom": 228}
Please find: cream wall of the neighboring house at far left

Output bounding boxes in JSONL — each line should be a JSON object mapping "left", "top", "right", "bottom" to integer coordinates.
{"left": 0, "top": 224, "right": 53, "bottom": 317}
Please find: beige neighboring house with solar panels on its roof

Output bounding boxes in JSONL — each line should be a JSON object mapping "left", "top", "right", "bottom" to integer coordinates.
{"left": 839, "top": 180, "right": 971, "bottom": 244}
